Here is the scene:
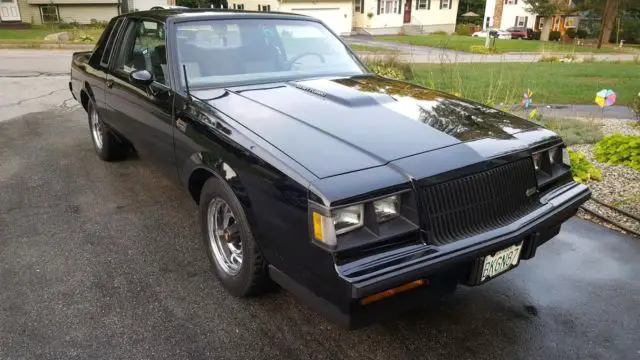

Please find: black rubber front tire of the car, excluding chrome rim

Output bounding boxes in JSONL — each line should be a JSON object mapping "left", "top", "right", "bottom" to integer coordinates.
{"left": 199, "top": 176, "right": 269, "bottom": 297}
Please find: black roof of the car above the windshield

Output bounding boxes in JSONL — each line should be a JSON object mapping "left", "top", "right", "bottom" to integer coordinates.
{"left": 121, "top": 8, "right": 315, "bottom": 22}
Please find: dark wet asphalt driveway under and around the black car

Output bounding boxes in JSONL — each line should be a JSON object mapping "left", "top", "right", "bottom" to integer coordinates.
{"left": 0, "top": 109, "right": 640, "bottom": 360}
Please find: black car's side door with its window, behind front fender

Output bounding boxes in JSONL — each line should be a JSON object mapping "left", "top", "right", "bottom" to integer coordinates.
{"left": 107, "top": 18, "right": 177, "bottom": 180}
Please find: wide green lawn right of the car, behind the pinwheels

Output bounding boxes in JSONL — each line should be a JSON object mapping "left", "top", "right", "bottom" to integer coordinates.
{"left": 413, "top": 62, "right": 640, "bottom": 105}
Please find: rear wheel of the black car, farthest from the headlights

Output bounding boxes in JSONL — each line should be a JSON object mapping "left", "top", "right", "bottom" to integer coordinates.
{"left": 87, "top": 99, "right": 129, "bottom": 161}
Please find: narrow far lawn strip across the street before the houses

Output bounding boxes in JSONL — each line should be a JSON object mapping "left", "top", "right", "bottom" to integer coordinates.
{"left": 378, "top": 35, "right": 637, "bottom": 53}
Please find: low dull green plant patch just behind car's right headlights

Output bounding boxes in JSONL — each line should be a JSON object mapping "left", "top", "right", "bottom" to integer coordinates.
{"left": 535, "top": 117, "right": 602, "bottom": 145}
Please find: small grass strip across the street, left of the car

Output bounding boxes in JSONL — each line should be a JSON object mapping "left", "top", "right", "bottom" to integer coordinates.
{"left": 0, "top": 26, "right": 103, "bottom": 44}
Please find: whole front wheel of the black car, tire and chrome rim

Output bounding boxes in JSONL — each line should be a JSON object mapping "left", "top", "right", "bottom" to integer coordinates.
{"left": 200, "top": 177, "right": 269, "bottom": 297}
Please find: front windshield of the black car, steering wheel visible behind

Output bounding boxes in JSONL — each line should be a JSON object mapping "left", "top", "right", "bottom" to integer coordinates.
{"left": 175, "top": 19, "right": 365, "bottom": 87}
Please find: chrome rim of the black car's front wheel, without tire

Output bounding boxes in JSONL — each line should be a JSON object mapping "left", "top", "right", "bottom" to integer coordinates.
{"left": 207, "top": 198, "right": 243, "bottom": 275}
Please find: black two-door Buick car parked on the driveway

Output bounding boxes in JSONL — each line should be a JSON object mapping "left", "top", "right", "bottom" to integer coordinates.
{"left": 69, "top": 10, "right": 590, "bottom": 326}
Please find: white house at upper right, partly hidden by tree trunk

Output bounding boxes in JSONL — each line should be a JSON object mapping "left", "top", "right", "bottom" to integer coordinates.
{"left": 482, "top": 0, "right": 579, "bottom": 33}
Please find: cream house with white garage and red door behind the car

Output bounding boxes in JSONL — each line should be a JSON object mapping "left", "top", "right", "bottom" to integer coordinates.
{"left": 229, "top": 0, "right": 459, "bottom": 35}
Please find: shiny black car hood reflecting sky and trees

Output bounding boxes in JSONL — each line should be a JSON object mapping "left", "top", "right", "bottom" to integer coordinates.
{"left": 194, "top": 75, "right": 552, "bottom": 178}
